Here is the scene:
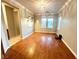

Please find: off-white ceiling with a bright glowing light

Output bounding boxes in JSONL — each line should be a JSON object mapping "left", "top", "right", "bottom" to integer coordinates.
{"left": 2, "top": 0, "right": 67, "bottom": 14}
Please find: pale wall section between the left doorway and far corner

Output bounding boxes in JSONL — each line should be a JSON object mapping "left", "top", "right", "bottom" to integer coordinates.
{"left": 21, "top": 8, "right": 34, "bottom": 38}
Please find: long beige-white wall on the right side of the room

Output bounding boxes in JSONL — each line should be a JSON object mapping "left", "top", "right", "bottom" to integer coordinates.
{"left": 58, "top": 0, "right": 77, "bottom": 55}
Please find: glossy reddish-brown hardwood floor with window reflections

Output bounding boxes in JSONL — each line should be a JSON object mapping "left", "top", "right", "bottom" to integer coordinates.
{"left": 5, "top": 33, "right": 76, "bottom": 59}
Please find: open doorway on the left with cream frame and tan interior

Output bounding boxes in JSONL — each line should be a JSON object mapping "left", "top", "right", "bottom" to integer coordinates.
{"left": 2, "top": 3, "right": 21, "bottom": 46}
